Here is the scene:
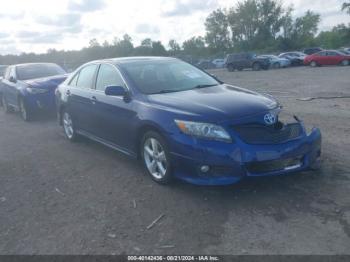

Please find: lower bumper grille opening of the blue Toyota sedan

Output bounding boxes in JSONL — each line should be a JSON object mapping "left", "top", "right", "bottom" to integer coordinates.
{"left": 246, "top": 157, "right": 303, "bottom": 174}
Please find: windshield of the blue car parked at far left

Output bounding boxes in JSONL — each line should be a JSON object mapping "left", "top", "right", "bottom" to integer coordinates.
{"left": 17, "top": 64, "right": 66, "bottom": 80}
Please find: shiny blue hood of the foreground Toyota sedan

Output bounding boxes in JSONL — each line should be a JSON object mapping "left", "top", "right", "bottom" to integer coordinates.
{"left": 149, "top": 84, "right": 278, "bottom": 123}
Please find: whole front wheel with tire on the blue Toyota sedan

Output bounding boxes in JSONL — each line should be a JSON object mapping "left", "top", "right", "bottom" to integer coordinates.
{"left": 140, "top": 131, "right": 172, "bottom": 185}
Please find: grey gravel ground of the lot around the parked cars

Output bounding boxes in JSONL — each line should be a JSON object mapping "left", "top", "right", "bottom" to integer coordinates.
{"left": 0, "top": 67, "right": 350, "bottom": 254}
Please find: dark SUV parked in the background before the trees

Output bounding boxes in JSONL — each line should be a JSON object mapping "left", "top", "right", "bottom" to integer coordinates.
{"left": 226, "top": 53, "right": 270, "bottom": 72}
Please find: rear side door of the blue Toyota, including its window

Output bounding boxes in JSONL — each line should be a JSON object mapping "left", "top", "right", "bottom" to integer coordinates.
{"left": 65, "top": 64, "right": 98, "bottom": 133}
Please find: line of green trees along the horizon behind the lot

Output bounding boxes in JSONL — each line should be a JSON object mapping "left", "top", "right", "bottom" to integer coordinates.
{"left": 0, "top": 0, "right": 350, "bottom": 69}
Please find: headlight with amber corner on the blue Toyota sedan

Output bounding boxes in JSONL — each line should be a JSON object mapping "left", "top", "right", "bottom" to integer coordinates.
{"left": 175, "top": 120, "right": 232, "bottom": 143}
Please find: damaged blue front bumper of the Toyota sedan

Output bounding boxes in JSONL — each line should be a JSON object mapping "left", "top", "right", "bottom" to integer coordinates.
{"left": 168, "top": 128, "right": 322, "bottom": 185}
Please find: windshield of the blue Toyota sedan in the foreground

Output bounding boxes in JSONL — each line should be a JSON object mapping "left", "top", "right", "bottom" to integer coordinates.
{"left": 121, "top": 60, "right": 220, "bottom": 94}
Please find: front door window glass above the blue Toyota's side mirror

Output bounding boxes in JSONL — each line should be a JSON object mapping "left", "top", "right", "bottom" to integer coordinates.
{"left": 96, "top": 64, "right": 124, "bottom": 91}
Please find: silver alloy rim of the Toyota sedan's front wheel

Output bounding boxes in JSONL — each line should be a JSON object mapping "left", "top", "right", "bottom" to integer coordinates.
{"left": 143, "top": 137, "right": 168, "bottom": 180}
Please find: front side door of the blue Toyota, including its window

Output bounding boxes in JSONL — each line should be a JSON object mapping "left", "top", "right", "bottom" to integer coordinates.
{"left": 93, "top": 64, "right": 135, "bottom": 149}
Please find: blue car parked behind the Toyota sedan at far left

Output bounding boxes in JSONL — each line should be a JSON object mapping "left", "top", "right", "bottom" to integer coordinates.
{"left": 1, "top": 63, "right": 67, "bottom": 121}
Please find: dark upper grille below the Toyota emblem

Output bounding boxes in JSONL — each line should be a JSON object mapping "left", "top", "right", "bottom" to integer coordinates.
{"left": 233, "top": 123, "right": 303, "bottom": 144}
